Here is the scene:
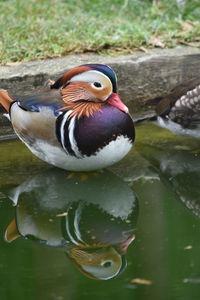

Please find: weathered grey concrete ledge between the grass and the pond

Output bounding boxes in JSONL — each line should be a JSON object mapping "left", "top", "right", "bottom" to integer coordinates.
{"left": 0, "top": 43, "right": 200, "bottom": 135}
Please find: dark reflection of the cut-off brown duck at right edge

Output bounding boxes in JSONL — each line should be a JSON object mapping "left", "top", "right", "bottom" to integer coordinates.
{"left": 139, "top": 146, "right": 200, "bottom": 218}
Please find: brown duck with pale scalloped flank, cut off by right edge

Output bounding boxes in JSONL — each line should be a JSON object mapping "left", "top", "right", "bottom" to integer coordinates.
{"left": 138, "top": 78, "right": 200, "bottom": 139}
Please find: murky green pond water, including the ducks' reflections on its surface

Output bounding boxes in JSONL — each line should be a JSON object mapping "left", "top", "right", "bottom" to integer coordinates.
{"left": 0, "top": 124, "right": 200, "bottom": 300}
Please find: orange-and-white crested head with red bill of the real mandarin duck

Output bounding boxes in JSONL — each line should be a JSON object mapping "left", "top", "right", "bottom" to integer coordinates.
{"left": 51, "top": 64, "right": 128, "bottom": 113}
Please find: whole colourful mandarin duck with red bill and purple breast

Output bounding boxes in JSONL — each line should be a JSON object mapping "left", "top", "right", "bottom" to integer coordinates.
{"left": 0, "top": 64, "right": 135, "bottom": 171}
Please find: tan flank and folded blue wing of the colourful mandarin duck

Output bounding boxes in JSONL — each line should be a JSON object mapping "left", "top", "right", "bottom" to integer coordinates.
{"left": 9, "top": 90, "right": 65, "bottom": 145}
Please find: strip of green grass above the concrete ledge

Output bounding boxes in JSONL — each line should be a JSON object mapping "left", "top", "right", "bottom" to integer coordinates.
{"left": 0, "top": 0, "right": 200, "bottom": 64}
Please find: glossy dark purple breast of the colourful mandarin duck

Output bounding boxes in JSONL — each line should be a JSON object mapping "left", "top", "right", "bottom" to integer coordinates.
{"left": 74, "top": 104, "right": 135, "bottom": 156}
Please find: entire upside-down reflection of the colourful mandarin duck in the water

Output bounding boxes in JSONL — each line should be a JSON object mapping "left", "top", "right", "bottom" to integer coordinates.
{"left": 5, "top": 169, "right": 138, "bottom": 280}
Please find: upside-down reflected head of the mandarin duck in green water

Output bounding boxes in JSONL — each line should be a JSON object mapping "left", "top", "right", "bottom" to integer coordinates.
{"left": 68, "top": 235, "right": 135, "bottom": 280}
